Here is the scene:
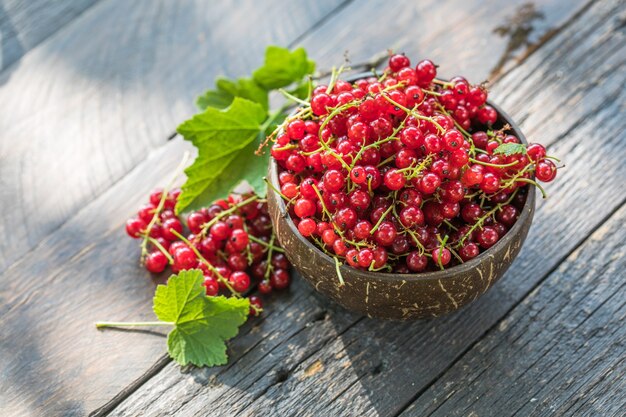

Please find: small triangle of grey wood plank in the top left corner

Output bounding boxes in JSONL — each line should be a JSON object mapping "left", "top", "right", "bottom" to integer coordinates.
{"left": 0, "top": 0, "right": 96, "bottom": 71}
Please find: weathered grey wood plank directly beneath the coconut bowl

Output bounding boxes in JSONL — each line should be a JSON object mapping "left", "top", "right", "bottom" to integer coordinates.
{"left": 107, "top": 2, "right": 626, "bottom": 415}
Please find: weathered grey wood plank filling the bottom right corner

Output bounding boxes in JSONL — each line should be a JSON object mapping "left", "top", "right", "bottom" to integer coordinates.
{"left": 402, "top": 206, "right": 626, "bottom": 417}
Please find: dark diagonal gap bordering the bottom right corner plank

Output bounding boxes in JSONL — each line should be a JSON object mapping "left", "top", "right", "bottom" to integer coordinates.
{"left": 393, "top": 198, "right": 626, "bottom": 417}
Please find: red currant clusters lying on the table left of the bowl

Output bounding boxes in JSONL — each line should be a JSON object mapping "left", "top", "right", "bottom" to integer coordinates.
{"left": 126, "top": 190, "right": 291, "bottom": 315}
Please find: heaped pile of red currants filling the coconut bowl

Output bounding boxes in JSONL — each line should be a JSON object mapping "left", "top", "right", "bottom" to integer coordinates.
{"left": 270, "top": 54, "right": 556, "bottom": 273}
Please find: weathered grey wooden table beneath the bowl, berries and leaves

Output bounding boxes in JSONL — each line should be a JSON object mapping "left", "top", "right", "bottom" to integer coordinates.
{"left": 0, "top": 0, "right": 626, "bottom": 416}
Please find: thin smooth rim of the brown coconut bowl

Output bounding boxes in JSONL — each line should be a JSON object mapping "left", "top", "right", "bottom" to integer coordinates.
{"left": 267, "top": 73, "right": 535, "bottom": 282}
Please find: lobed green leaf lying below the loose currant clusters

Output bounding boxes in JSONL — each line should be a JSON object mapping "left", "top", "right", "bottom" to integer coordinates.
{"left": 154, "top": 269, "right": 250, "bottom": 366}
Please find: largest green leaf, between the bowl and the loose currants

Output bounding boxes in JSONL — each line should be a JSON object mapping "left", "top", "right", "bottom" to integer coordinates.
{"left": 176, "top": 97, "right": 267, "bottom": 212}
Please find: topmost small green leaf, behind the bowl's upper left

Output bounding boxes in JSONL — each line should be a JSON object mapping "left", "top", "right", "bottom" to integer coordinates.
{"left": 253, "top": 46, "right": 315, "bottom": 90}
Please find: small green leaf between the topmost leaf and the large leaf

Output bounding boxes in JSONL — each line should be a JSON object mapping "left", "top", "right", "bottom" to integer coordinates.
{"left": 196, "top": 78, "right": 269, "bottom": 110}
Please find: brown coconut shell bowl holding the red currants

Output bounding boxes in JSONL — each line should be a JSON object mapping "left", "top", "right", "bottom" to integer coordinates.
{"left": 268, "top": 96, "right": 535, "bottom": 320}
